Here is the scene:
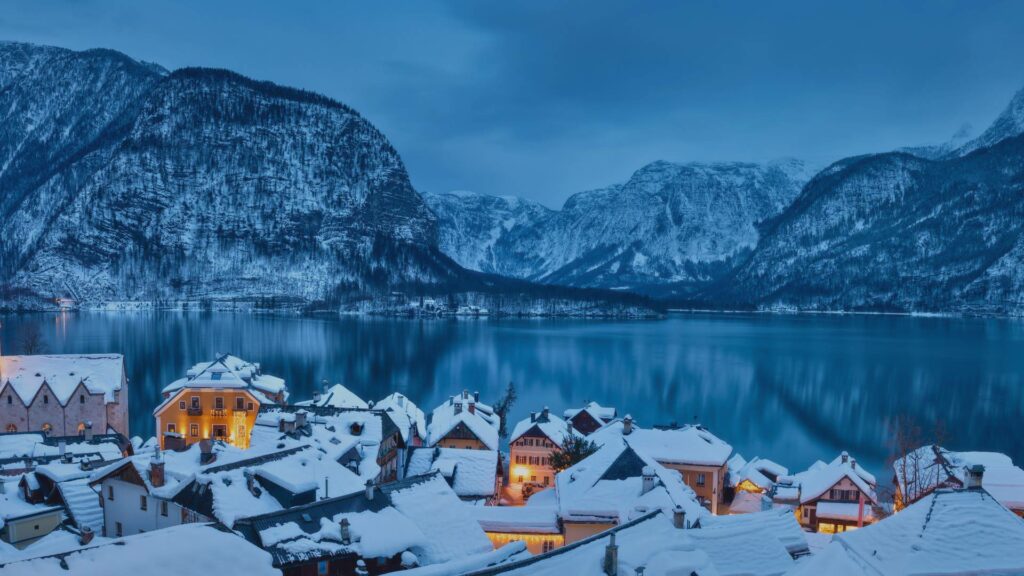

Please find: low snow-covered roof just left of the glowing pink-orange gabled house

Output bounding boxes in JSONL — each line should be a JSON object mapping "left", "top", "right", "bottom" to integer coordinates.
{"left": 406, "top": 446, "right": 502, "bottom": 505}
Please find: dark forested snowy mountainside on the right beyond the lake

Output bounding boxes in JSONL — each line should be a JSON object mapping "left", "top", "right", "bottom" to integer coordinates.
{"left": 705, "top": 136, "right": 1024, "bottom": 314}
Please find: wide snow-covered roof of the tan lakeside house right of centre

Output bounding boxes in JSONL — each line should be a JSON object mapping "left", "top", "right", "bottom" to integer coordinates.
{"left": 590, "top": 420, "right": 732, "bottom": 466}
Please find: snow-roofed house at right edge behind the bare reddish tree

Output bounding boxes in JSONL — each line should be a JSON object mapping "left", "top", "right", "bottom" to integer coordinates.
{"left": 893, "top": 445, "right": 1024, "bottom": 517}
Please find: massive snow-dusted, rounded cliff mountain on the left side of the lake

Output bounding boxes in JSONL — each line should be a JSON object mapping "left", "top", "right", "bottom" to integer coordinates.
{"left": 0, "top": 44, "right": 452, "bottom": 302}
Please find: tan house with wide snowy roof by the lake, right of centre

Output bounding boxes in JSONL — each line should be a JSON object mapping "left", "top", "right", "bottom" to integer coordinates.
{"left": 591, "top": 414, "right": 732, "bottom": 515}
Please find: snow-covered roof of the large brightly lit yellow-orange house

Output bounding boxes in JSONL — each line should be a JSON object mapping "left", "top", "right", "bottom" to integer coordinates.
{"left": 162, "top": 355, "right": 288, "bottom": 404}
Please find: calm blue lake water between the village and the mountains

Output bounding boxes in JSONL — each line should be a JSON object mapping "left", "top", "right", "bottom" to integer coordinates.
{"left": 0, "top": 313, "right": 1024, "bottom": 472}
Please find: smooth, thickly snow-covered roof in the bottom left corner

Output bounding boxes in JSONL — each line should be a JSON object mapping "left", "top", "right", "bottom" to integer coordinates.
{"left": 0, "top": 524, "right": 281, "bottom": 576}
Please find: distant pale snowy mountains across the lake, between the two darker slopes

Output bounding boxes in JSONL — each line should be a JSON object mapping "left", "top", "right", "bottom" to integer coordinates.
{"left": 428, "top": 161, "right": 806, "bottom": 294}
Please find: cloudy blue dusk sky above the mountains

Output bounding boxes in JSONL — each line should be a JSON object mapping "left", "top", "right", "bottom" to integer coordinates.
{"left": 0, "top": 0, "right": 1024, "bottom": 207}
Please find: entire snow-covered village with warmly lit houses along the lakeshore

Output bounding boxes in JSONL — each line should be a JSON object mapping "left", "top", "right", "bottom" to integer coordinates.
{"left": 0, "top": 354, "right": 1024, "bottom": 576}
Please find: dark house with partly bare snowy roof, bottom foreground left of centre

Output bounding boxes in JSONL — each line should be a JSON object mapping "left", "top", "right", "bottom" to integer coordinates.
{"left": 236, "top": 474, "right": 492, "bottom": 576}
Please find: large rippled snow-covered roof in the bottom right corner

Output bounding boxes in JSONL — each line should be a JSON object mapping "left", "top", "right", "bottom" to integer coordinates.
{"left": 793, "top": 489, "right": 1024, "bottom": 576}
